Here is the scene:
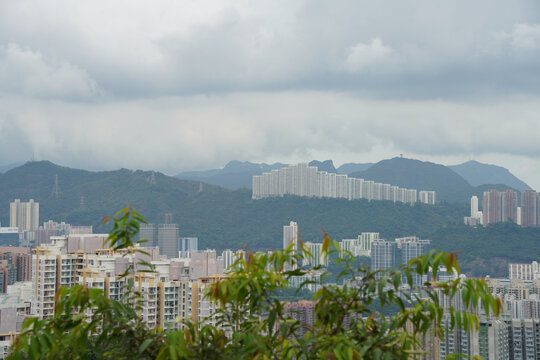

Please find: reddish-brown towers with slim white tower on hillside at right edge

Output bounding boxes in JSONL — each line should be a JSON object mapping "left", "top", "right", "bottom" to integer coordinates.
{"left": 464, "top": 190, "right": 540, "bottom": 227}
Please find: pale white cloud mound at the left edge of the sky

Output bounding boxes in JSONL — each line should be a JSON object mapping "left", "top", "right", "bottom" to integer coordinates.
{"left": 0, "top": 43, "right": 100, "bottom": 99}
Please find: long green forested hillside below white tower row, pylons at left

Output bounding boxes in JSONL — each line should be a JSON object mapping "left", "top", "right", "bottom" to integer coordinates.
{"left": 0, "top": 161, "right": 467, "bottom": 248}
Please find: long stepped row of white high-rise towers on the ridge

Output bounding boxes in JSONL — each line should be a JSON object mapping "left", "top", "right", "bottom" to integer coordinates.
{"left": 252, "top": 163, "right": 436, "bottom": 204}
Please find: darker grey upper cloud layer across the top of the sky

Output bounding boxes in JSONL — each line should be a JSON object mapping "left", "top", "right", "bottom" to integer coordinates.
{"left": 0, "top": 0, "right": 540, "bottom": 99}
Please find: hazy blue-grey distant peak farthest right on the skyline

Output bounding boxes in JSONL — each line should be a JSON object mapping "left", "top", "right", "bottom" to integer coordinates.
{"left": 448, "top": 160, "right": 531, "bottom": 192}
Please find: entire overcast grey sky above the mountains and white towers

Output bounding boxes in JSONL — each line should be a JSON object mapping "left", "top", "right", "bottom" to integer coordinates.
{"left": 0, "top": 0, "right": 540, "bottom": 189}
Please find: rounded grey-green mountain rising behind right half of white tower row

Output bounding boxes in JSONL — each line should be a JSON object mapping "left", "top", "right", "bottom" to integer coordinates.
{"left": 350, "top": 157, "right": 475, "bottom": 202}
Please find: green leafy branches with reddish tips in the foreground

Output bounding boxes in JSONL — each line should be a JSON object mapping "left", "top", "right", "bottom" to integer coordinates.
{"left": 10, "top": 208, "right": 501, "bottom": 359}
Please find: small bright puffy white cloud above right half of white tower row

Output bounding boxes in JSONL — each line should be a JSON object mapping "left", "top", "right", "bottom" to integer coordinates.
{"left": 345, "top": 38, "right": 392, "bottom": 72}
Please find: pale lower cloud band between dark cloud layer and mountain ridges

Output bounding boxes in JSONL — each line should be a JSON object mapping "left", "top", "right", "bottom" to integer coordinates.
{"left": 0, "top": 92, "right": 540, "bottom": 187}
